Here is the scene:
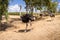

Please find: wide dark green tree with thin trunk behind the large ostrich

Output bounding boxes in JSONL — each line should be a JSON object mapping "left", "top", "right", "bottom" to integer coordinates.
{"left": 24, "top": 0, "right": 50, "bottom": 14}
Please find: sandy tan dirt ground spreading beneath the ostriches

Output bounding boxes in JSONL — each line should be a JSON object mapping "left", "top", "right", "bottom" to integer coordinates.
{"left": 0, "top": 15, "right": 60, "bottom": 40}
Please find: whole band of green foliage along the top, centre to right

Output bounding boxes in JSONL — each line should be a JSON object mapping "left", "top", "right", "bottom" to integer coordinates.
{"left": 24, "top": 0, "right": 57, "bottom": 12}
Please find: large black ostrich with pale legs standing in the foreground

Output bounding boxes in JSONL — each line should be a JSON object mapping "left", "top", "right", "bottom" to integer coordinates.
{"left": 21, "top": 14, "right": 34, "bottom": 32}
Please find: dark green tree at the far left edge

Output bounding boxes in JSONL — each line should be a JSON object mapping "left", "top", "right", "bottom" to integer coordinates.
{"left": 0, "top": 0, "right": 9, "bottom": 26}
